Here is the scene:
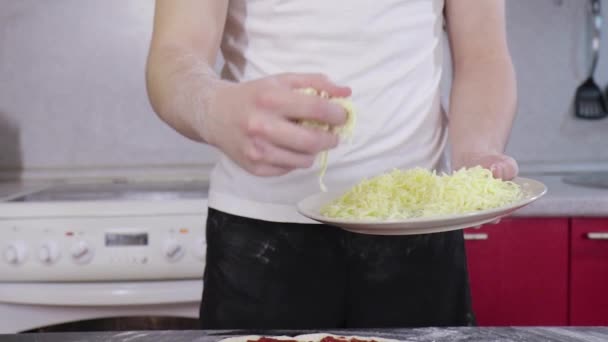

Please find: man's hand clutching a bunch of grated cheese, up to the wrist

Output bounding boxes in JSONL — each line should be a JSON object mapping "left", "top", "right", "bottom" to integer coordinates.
{"left": 202, "top": 73, "right": 351, "bottom": 177}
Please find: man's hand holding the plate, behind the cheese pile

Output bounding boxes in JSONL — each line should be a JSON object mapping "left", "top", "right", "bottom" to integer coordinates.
{"left": 453, "top": 152, "right": 519, "bottom": 180}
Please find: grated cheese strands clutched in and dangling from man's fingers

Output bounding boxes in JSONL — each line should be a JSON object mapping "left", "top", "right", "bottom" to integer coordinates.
{"left": 298, "top": 88, "right": 357, "bottom": 192}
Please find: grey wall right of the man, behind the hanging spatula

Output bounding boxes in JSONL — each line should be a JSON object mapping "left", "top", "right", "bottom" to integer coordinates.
{"left": 498, "top": 0, "right": 608, "bottom": 169}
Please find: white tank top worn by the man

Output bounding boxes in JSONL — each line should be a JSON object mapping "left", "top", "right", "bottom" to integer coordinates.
{"left": 209, "top": 0, "right": 446, "bottom": 223}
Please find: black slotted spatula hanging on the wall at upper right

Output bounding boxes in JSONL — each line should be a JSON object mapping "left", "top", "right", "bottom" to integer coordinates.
{"left": 574, "top": 0, "right": 608, "bottom": 119}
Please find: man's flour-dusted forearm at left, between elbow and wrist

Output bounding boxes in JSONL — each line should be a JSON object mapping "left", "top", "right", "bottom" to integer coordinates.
{"left": 146, "top": 48, "right": 224, "bottom": 142}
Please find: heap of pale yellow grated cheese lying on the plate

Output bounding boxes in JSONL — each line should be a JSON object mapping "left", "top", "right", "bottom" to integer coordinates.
{"left": 321, "top": 166, "right": 522, "bottom": 220}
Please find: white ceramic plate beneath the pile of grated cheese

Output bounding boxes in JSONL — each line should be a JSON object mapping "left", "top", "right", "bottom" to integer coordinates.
{"left": 297, "top": 177, "right": 547, "bottom": 235}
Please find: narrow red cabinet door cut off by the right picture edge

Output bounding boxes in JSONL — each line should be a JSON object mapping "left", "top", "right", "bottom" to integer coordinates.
{"left": 570, "top": 218, "right": 608, "bottom": 325}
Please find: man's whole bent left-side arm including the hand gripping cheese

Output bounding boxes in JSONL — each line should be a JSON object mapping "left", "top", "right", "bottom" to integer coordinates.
{"left": 146, "top": 0, "right": 351, "bottom": 176}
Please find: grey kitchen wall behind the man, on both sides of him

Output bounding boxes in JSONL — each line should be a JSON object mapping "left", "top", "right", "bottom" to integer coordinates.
{"left": 0, "top": 0, "right": 608, "bottom": 177}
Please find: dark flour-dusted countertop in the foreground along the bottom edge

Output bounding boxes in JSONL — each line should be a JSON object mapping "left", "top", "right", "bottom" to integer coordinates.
{"left": 0, "top": 327, "right": 608, "bottom": 342}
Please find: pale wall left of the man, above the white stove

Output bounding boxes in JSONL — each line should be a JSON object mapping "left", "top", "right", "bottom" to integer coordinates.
{"left": 0, "top": 0, "right": 215, "bottom": 179}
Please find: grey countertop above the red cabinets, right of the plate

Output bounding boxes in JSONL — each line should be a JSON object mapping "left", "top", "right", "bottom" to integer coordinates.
{"left": 513, "top": 174, "right": 608, "bottom": 217}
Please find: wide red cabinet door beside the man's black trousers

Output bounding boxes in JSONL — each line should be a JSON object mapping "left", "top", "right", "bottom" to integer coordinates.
{"left": 465, "top": 218, "right": 568, "bottom": 326}
